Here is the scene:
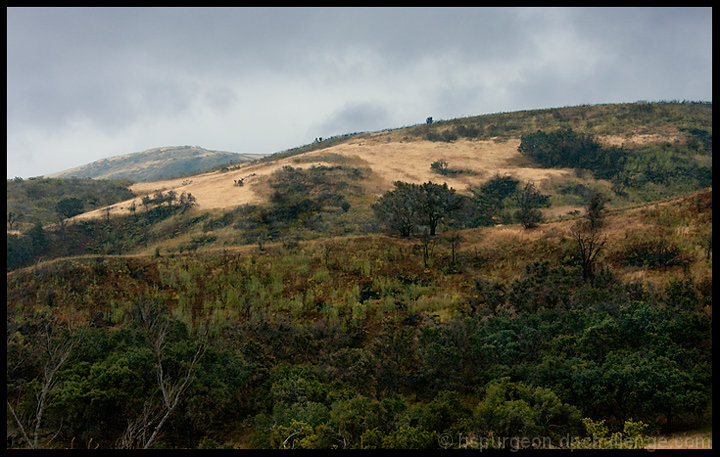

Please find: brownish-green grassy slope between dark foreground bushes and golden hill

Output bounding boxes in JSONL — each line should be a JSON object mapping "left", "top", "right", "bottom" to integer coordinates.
{"left": 7, "top": 190, "right": 712, "bottom": 448}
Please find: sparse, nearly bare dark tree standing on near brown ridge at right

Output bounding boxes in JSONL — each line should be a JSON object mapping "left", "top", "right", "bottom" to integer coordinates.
{"left": 571, "top": 192, "right": 607, "bottom": 281}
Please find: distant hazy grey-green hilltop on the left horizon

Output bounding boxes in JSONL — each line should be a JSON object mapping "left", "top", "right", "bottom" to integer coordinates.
{"left": 45, "top": 146, "right": 266, "bottom": 182}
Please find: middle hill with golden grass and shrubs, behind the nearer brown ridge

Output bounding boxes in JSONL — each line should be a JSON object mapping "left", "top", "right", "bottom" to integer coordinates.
{"left": 9, "top": 102, "right": 712, "bottom": 265}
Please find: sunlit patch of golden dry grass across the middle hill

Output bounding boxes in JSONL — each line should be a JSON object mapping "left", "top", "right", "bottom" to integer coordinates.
{"left": 70, "top": 134, "right": 571, "bottom": 219}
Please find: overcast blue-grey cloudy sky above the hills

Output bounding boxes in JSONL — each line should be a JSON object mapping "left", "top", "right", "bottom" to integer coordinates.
{"left": 6, "top": 7, "right": 712, "bottom": 178}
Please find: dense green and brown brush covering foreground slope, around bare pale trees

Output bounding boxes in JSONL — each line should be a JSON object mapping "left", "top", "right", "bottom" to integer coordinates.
{"left": 7, "top": 235, "right": 712, "bottom": 448}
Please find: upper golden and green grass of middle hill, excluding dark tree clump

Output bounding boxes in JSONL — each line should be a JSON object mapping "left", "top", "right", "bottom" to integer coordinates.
{"left": 66, "top": 103, "right": 712, "bottom": 223}
